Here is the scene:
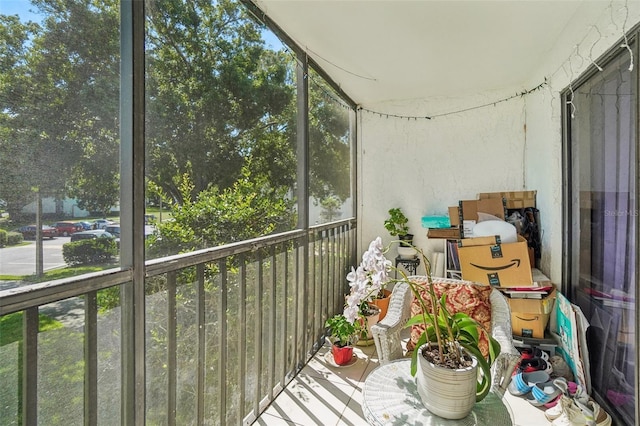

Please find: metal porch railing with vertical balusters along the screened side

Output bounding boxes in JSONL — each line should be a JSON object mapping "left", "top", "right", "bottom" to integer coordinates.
{"left": 0, "top": 220, "right": 355, "bottom": 425}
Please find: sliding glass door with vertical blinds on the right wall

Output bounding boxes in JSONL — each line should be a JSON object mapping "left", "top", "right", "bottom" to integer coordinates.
{"left": 565, "top": 35, "right": 638, "bottom": 424}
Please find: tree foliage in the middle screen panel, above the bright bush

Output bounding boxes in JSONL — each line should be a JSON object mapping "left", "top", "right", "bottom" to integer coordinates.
{"left": 147, "top": 0, "right": 295, "bottom": 203}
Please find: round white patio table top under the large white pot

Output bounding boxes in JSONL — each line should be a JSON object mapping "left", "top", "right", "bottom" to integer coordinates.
{"left": 362, "top": 359, "right": 512, "bottom": 426}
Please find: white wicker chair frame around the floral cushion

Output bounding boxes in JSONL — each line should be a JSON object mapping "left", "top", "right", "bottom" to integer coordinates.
{"left": 371, "top": 276, "right": 520, "bottom": 396}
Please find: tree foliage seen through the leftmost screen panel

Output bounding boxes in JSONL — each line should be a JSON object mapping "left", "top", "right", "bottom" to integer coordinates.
{"left": 0, "top": 0, "right": 119, "bottom": 218}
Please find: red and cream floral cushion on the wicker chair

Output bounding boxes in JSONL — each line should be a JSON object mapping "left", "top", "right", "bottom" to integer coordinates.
{"left": 407, "top": 277, "right": 492, "bottom": 356}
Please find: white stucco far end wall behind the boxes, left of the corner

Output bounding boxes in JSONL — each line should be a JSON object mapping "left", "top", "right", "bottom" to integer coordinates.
{"left": 358, "top": 92, "right": 526, "bottom": 276}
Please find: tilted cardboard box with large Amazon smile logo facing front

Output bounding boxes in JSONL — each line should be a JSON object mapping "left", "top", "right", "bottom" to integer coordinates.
{"left": 458, "top": 235, "right": 533, "bottom": 287}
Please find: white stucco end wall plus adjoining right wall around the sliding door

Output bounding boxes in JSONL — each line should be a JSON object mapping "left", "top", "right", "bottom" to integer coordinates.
{"left": 358, "top": 2, "right": 640, "bottom": 284}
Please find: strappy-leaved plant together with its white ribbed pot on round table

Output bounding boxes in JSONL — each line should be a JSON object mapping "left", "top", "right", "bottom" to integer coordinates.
{"left": 400, "top": 243, "right": 500, "bottom": 419}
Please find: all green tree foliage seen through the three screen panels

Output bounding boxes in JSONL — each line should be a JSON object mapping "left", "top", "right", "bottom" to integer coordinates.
{"left": 0, "top": 0, "right": 350, "bottom": 245}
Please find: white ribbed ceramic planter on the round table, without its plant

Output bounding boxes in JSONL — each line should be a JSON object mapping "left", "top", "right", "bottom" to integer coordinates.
{"left": 416, "top": 345, "right": 478, "bottom": 419}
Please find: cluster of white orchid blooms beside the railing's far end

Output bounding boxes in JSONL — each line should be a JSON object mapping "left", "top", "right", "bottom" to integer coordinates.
{"left": 344, "top": 237, "right": 391, "bottom": 323}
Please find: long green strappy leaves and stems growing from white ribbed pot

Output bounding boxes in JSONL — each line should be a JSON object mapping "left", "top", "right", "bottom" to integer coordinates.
{"left": 398, "top": 243, "right": 500, "bottom": 401}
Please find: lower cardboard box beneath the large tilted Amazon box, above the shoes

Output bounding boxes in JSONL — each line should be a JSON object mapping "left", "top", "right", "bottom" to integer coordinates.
{"left": 507, "top": 289, "right": 556, "bottom": 339}
